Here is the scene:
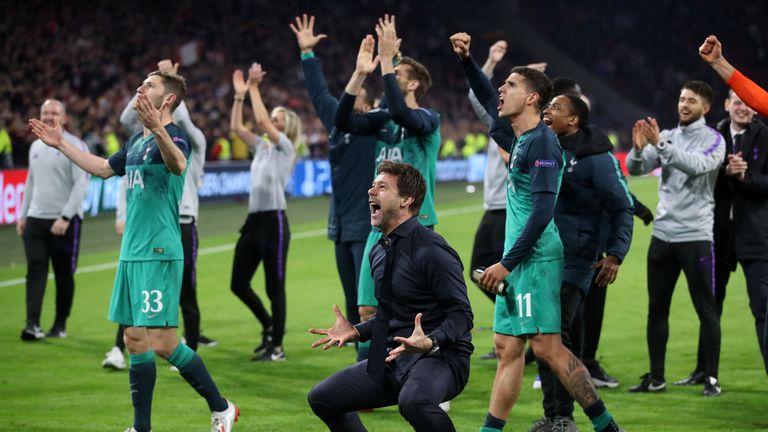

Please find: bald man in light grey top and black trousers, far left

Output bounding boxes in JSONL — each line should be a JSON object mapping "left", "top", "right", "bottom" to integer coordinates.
{"left": 16, "top": 99, "right": 90, "bottom": 341}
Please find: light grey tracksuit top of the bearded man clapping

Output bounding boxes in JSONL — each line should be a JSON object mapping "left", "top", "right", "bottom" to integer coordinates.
{"left": 627, "top": 117, "right": 725, "bottom": 243}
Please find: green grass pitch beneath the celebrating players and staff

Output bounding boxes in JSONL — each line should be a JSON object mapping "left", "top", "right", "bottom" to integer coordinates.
{"left": 0, "top": 179, "right": 768, "bottom": 431}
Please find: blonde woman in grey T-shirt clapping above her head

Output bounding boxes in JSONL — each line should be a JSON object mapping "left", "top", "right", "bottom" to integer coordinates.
{"left": 230, "top": 63, "right": 301, "bottom": 361}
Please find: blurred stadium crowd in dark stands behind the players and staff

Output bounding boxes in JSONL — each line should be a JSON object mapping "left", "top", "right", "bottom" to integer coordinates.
{"left": 0, "top": 0, "right": 768, "bottom": 167}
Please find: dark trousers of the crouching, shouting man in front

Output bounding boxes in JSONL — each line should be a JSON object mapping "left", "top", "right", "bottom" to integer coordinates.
{"left": 308, "top": 354, "right": 469, "bottom": 432}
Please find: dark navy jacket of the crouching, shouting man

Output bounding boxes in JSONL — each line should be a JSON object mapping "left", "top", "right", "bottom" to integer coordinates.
{"left": 356, "top": 217, "right": 474, "bottom": 368}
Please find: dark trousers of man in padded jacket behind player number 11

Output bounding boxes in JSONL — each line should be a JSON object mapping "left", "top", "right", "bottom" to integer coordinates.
{"left": 536, "top": 282, "right": 584, "bottom": 418}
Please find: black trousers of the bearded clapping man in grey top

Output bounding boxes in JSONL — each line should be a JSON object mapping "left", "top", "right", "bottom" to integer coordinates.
{"left": 647, "top": 237, "right": 720, "bottom": 380}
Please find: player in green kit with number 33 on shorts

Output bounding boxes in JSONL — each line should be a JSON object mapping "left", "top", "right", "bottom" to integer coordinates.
{"left": 29, "top": 71, "right": 238, "bottom": 432}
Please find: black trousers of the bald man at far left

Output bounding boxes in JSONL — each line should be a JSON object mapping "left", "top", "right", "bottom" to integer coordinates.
{"left": 22, "top": 216, "right": 82, "bottom": 329}
